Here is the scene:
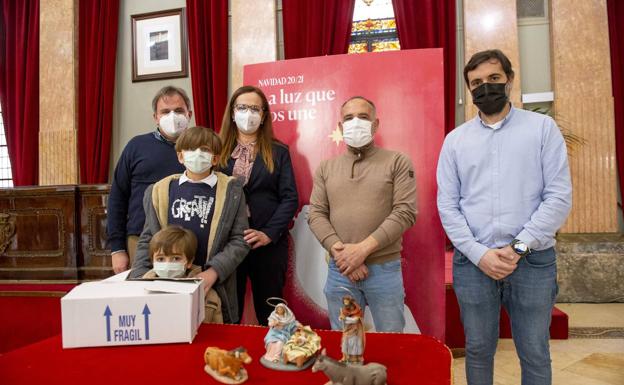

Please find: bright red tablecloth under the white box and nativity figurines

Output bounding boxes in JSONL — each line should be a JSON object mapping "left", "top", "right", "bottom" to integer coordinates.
{"left": 0, "top": 324, "right": 452, "bottom": 385}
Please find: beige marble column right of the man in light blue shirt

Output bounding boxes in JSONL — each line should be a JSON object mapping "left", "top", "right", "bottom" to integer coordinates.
{"left": 550, "top": 0, "right": 618, "bottom": 233}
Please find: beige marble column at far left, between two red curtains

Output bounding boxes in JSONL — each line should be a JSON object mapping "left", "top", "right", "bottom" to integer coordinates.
{"left": 39, "top": 0, "right": 79, "bottom": 185}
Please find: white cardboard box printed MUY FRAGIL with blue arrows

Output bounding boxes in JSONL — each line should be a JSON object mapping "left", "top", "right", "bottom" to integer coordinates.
{"left": 61, "top": 275, "right": 204, "bottom": 348}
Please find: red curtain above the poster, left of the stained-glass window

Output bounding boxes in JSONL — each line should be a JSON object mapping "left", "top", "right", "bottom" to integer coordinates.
{"left": 282, "top": 0, "right": 355, "bottom": 59}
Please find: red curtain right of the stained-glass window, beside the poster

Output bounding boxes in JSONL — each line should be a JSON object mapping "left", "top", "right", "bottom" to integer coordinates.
{"left": 392, "top": 0, "right": 456, "bottom": 133}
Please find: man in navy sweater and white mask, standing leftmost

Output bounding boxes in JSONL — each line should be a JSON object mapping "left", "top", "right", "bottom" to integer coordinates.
{"left": 106, "top": 86, "right": 193, "bottom": 274}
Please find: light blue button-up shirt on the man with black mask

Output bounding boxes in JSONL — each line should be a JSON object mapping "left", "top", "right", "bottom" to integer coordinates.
{"left": 437, "top": 106, "right": 572, "bottom": 265}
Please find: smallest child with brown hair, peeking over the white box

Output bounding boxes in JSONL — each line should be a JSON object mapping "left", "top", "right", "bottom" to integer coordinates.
{"left": 143, "top": 225, "right": 223, "bottom": 323}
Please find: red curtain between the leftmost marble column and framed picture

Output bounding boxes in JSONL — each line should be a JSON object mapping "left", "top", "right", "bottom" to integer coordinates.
{"left": 78, "top": 0, "right": 119, "bottom": 184}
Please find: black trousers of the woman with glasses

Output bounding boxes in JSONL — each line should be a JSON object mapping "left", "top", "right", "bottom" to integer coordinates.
{"left": 236, "top": 234, "right": 288, "bottom": 326}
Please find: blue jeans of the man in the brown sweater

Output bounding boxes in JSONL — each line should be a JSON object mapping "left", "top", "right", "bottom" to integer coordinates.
{"left": 324, "top": 259, "right": 405, "bottom": 332}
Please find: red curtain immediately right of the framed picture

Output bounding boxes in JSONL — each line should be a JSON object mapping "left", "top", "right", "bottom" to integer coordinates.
{"left": 186, "top": 0, "right": 228, "bottom": 131}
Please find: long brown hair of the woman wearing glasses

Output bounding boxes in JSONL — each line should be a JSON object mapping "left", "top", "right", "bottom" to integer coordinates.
{"left": 219, "top": 86, "right": 279, "bottom": 173}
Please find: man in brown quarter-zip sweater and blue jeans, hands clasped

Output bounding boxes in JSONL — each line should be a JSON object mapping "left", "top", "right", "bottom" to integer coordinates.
{"left": 308, "top": 96, "right": 417, "bottom": 332}
